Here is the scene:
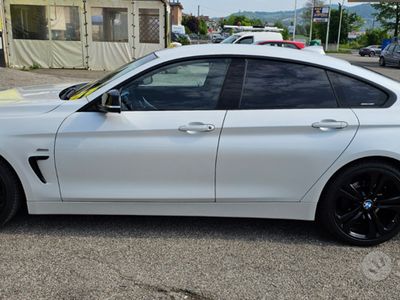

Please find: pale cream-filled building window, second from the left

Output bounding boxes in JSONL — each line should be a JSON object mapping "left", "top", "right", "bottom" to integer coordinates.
{"left": 50, "top": 6, "right": 81, "bottom": 41}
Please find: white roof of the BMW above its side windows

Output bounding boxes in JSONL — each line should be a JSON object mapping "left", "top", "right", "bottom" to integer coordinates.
{"left": 156, "top": 44, "right": 351, "bottom": 69}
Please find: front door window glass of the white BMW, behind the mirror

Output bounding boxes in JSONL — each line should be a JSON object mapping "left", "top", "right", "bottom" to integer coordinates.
{"left": 121, "top": 58, "right": 230, "bottom": 111}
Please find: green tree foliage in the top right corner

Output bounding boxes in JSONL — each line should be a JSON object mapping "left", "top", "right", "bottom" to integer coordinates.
{"left": 371, "top": 2, "right": 400, "bottom": 37}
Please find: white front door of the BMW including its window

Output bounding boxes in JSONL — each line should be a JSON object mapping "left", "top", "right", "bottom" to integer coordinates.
{"left": 56, "top": 59, "right": 230, "bottom": 202}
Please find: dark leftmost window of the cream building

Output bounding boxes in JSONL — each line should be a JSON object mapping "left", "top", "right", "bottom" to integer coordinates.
{"left": 10, "top": 4, "right": 49, "bottom": 40}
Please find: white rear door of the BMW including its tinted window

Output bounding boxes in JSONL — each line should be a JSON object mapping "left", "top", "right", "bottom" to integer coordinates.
{"left": 216, "top": 59, "right": 359, "bottom": 202}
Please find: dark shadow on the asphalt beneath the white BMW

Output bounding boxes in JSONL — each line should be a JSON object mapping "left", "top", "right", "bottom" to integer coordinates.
{"left": 0, "top": 212, "right": 362, "bottom": 246}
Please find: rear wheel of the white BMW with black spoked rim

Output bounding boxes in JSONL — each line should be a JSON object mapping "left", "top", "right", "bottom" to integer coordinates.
{"left": 317, "top": 161, "right": 400, "bottom": 246}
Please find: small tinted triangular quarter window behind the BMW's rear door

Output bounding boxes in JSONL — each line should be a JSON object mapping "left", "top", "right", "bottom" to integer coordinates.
{"left": 328, "top": 72, "right": 388, "bottom": 107}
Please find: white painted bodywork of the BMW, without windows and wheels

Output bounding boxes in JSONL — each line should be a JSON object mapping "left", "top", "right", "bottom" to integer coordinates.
{"left": 0, "top": 45, "right": 400, "bottom": 220}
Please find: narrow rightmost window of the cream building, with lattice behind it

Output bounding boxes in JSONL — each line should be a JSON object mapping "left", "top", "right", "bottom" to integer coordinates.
{"left": 139, "top": 8, "right": 160, "bottom": 44}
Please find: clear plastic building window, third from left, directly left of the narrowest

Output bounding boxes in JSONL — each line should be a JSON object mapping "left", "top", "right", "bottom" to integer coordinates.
{"left": 91, "top": 7, "right": 128, "bottom": 43}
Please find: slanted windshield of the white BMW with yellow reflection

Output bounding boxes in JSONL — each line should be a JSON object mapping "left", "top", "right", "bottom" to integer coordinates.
{"left": 67, "top": 52, "right": 158, "bottom": 100}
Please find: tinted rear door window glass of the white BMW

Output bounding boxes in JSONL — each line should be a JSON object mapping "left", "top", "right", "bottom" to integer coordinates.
{"left": 240, "top": 60, "right": 337, "bottom": 109}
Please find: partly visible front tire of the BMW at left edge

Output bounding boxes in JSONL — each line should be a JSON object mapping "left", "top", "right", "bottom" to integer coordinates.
{"left": 0, "top": 160, "right": 24, "bottom": 225}
